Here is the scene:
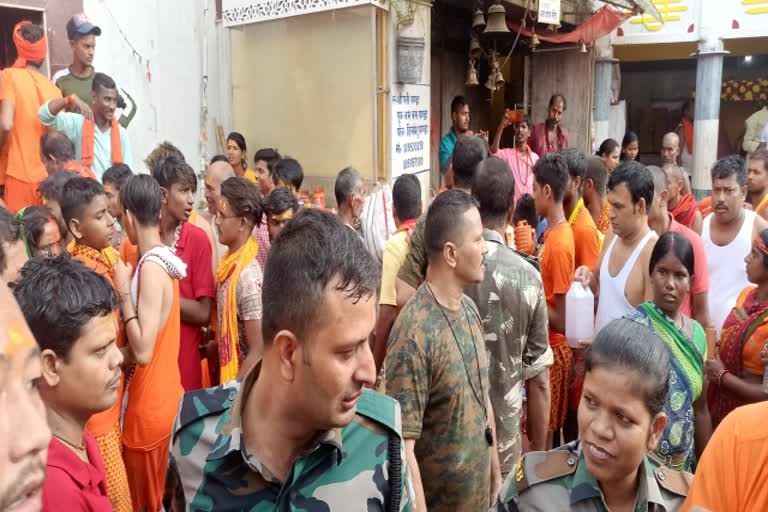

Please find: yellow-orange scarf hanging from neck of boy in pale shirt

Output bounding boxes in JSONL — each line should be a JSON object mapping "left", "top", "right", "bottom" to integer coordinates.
{"left": 216, "top": 236, "right": 259, "bottom": 383}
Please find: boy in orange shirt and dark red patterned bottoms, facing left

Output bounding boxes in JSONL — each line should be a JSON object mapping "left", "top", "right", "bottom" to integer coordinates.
{"left": 533, "top": 153, "right": 576, "bottom": 447}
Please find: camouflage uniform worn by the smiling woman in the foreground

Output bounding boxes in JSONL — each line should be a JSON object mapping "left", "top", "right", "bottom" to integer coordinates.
{"left": 492, "top": 441, "right": 693, "bottom": 512}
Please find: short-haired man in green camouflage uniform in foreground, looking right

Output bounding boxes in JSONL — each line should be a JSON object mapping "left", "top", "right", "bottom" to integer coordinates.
{"left": 164, "top": 210, "right": 412, "bottom": 512}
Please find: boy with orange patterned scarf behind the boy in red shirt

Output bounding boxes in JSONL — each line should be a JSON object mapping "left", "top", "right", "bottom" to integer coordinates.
{"left": 60, "top": 177, "right": 132, "bottom": 512}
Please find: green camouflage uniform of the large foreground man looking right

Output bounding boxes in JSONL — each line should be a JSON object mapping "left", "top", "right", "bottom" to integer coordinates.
{"left": 164, "top": 365, "right": 413, "bottom": 512}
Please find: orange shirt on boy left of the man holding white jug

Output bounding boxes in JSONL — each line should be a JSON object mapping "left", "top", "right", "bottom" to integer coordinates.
{"left": 539, "top": 222, "right": 576, "bottom": 347}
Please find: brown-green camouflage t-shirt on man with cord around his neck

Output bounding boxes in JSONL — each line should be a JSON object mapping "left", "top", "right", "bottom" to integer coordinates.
{"left": 384, "top": 283, "right": 491, "bottom": 512}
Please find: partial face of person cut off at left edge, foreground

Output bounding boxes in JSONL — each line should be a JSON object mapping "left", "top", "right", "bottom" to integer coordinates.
{"left": 0, "top": 270, "right": 51, "bottom": 511}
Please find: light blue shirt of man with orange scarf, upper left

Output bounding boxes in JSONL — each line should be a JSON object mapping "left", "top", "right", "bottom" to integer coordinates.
{"left": 38, "top": 103, "right": 133, "bottom": 181}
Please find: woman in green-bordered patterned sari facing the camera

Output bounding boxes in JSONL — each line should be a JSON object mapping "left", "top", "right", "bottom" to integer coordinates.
{"left": 632, "top": 231, "right": 712, "bottom": 471}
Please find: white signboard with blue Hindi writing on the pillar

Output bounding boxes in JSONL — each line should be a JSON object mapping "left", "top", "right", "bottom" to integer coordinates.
{"left": 390, "top": 84, "right": 430, "bottom": 180}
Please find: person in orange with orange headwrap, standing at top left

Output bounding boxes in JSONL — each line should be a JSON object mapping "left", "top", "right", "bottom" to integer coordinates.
{"left": 0, "top": 21, "right": 87, "bottom": 213}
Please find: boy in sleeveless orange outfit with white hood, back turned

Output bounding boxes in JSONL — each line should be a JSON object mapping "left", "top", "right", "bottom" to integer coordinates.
{"left": 115, "top": 174, "right": 186, "bottom": 512}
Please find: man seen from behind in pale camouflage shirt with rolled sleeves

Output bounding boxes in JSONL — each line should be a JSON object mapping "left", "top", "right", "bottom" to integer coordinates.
{"left": 467, "top": 158, "right": 552, "bottom": 476}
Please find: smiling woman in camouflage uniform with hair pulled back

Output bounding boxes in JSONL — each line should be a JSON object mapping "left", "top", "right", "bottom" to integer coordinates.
{"left": 496, "top": 318, "right": 691, "bottom": 512}
